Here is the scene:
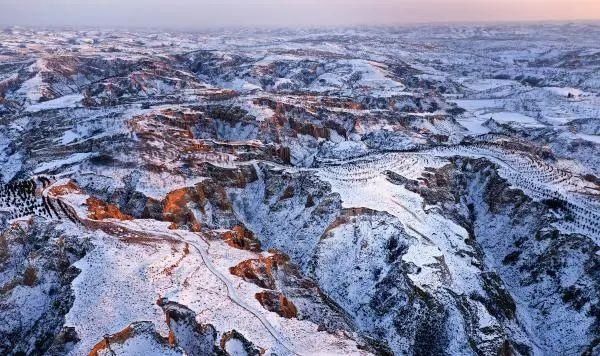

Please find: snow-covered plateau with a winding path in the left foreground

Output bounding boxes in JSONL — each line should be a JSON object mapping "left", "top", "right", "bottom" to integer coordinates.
{"left": 65, "top": 195, "right": 370, "bottom": 355}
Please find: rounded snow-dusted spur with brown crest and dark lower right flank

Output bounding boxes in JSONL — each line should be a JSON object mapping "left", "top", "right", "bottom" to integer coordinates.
{"left": 311, "top": 209, "right": 465, "bottom": 355}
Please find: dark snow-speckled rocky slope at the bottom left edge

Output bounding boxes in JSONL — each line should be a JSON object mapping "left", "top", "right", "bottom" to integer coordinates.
{"left": 0, "top": 218, "right": 89, "bottom": 355}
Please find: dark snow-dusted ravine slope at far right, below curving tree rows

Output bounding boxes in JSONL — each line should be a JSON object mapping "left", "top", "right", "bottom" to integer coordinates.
{"left": 407, "top": 159, "right": 600, "bottom": 353}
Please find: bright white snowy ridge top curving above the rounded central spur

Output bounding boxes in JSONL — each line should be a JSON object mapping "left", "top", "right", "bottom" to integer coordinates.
{"left": 317, "top": 153, "right": 477, "bottom": 293}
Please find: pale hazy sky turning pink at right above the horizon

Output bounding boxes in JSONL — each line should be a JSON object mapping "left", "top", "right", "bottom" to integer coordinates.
{"left": 0, "top": 0, "right": 600, "bottom": 29}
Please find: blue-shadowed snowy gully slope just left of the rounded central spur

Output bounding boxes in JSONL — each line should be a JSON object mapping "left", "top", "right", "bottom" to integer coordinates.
{"left": 229, "top": 165, "right": 341, "bottom": 270}
